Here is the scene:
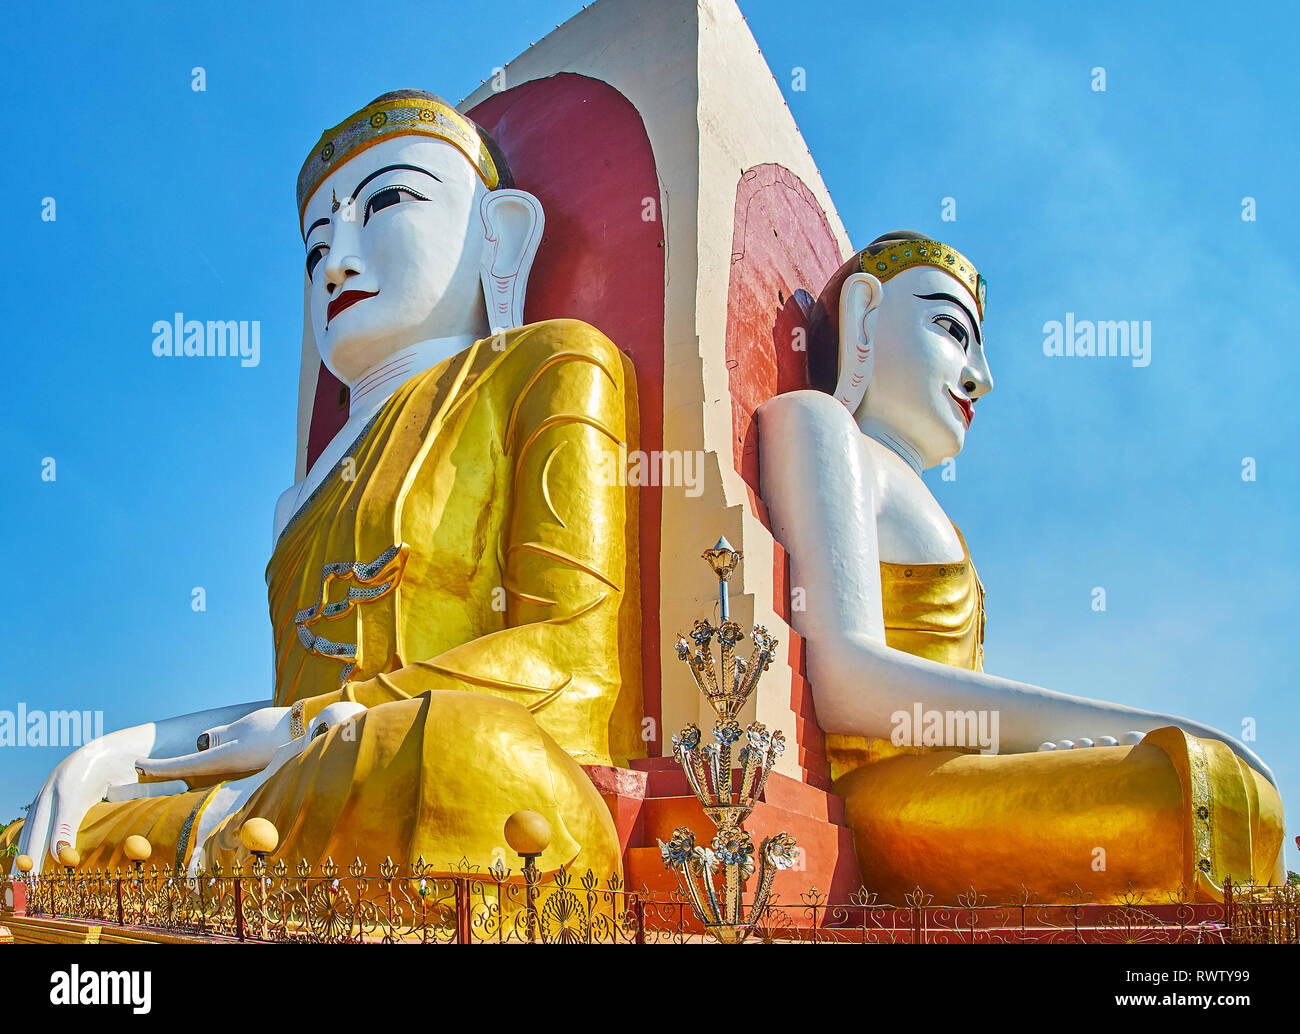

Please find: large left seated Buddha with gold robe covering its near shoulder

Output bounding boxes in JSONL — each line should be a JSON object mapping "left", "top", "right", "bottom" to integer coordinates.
{"left": 10, "top": 91, "right": 641, "bottom": 873}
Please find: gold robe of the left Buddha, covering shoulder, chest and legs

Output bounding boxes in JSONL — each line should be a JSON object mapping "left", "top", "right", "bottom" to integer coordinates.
{"left": 52, "top": 320, "right": 644, "bottom": 874}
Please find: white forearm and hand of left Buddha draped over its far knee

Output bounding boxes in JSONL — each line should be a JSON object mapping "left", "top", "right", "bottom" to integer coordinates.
{"left": 20, "top": 704, "right": 274, "bottom": 873}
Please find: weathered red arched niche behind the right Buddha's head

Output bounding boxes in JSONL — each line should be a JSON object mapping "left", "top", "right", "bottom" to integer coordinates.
{"left": 727, "top": 165, "right": 844, "bottom": 528}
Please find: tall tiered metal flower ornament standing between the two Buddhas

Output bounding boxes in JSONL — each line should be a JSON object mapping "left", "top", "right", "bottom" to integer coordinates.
{"left": 659, "top": 538, "right": 796, "bottom": 944}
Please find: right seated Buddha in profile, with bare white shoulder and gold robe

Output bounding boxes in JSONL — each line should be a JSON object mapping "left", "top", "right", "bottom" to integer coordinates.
{"left": 758, "top": 232, "right": 1284, "bottom": 903}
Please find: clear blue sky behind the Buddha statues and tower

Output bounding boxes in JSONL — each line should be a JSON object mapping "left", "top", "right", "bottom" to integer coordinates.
{"left": 0, "top": 0, "right": 1300, "bottom": 868}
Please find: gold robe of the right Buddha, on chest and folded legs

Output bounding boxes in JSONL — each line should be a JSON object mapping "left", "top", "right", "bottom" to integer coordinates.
{"left": 827, "top": 533, "right": 1284, "bottom": 904}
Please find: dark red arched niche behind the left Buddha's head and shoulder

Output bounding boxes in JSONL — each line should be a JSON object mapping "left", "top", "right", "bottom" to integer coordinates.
{"left": 468, "top": 73, "right": 664, "bottom": 749}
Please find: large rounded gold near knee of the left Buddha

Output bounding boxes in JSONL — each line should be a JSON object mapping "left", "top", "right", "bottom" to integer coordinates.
{"left": 216, "top": 691, "right": 618, "bottom": 870}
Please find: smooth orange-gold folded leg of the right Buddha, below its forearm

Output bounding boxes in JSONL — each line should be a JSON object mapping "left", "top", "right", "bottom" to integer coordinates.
{"left": 836, "top": 745, "right": 1187, "bottom": 900}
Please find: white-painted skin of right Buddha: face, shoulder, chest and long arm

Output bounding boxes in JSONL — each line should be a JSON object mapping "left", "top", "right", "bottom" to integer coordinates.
{"left": 758, "top": 268, "right": 1273, "bottom": 780}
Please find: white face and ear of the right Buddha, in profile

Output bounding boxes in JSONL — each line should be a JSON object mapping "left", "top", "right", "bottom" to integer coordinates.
{"left": 840, "top": 265, "right": 993, "bottom": 468}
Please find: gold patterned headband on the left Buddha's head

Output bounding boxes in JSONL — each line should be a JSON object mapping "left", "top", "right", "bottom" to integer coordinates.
{"left": 298, "top": 95, "right": 501, "bottom": 225}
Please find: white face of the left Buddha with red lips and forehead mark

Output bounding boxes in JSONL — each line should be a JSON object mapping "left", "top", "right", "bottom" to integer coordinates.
{"left": 303, "top": 135, "right": 488, "bottom": 384}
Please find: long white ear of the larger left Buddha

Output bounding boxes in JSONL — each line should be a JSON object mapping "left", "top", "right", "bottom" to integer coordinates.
{"left": 478, "top": 190, "right": 546, "bottom": 333}
